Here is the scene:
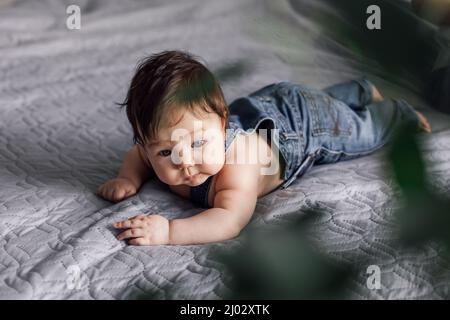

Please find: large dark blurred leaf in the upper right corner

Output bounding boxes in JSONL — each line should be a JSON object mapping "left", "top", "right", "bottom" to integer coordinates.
{"left": 312, "top": 0, "right": 439, "bottom": 91}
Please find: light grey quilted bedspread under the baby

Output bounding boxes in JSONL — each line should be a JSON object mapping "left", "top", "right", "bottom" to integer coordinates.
{"left": 0, "top": 0, "right": 450, "bottom": 299}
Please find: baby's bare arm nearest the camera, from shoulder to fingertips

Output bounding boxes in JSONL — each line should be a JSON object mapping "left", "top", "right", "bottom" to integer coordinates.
{"left": 114, "top": 164, "right": 260, "bottom": 245}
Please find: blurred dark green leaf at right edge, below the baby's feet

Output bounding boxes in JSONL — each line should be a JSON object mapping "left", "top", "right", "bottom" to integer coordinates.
{"left": 387, "top": 122, "right": 450, "bottom": 248}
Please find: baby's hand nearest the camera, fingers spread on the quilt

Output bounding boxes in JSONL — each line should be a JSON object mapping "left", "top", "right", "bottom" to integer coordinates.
{"left": 113, "top": 214, "right": 169, "bottom": 246}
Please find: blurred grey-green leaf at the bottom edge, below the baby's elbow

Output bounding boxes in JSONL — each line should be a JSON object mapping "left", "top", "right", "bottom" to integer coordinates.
{"left": 217, "top": 211, "right": 351, "bottom": 299}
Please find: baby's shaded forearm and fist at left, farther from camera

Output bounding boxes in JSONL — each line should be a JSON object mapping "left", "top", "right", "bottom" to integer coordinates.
{"left": 97, "top": 145, "right": 154, "bottom": 202}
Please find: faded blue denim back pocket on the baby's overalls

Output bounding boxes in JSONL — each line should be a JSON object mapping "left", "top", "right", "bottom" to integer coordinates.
{"left": 302, "top": 92, "right": 352, "bottom": 137}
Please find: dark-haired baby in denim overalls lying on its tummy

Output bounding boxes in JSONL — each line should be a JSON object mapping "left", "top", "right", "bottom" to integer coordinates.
{"left": 98, "top": 51, "right": 431, "bottom": 245}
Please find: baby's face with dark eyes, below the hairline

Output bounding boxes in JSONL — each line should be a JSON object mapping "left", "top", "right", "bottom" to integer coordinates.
{"left": 144, "top": 111, "right": 225, "bottom": 186}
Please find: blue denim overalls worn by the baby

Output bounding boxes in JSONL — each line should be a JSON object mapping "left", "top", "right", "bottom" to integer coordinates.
{"left": 191, "top": 79, "right": 419, "bottom": 208}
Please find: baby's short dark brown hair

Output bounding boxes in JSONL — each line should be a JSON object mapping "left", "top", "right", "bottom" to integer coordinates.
{"left": 119, "top": 51, "right": 229, "bottom": 145}
